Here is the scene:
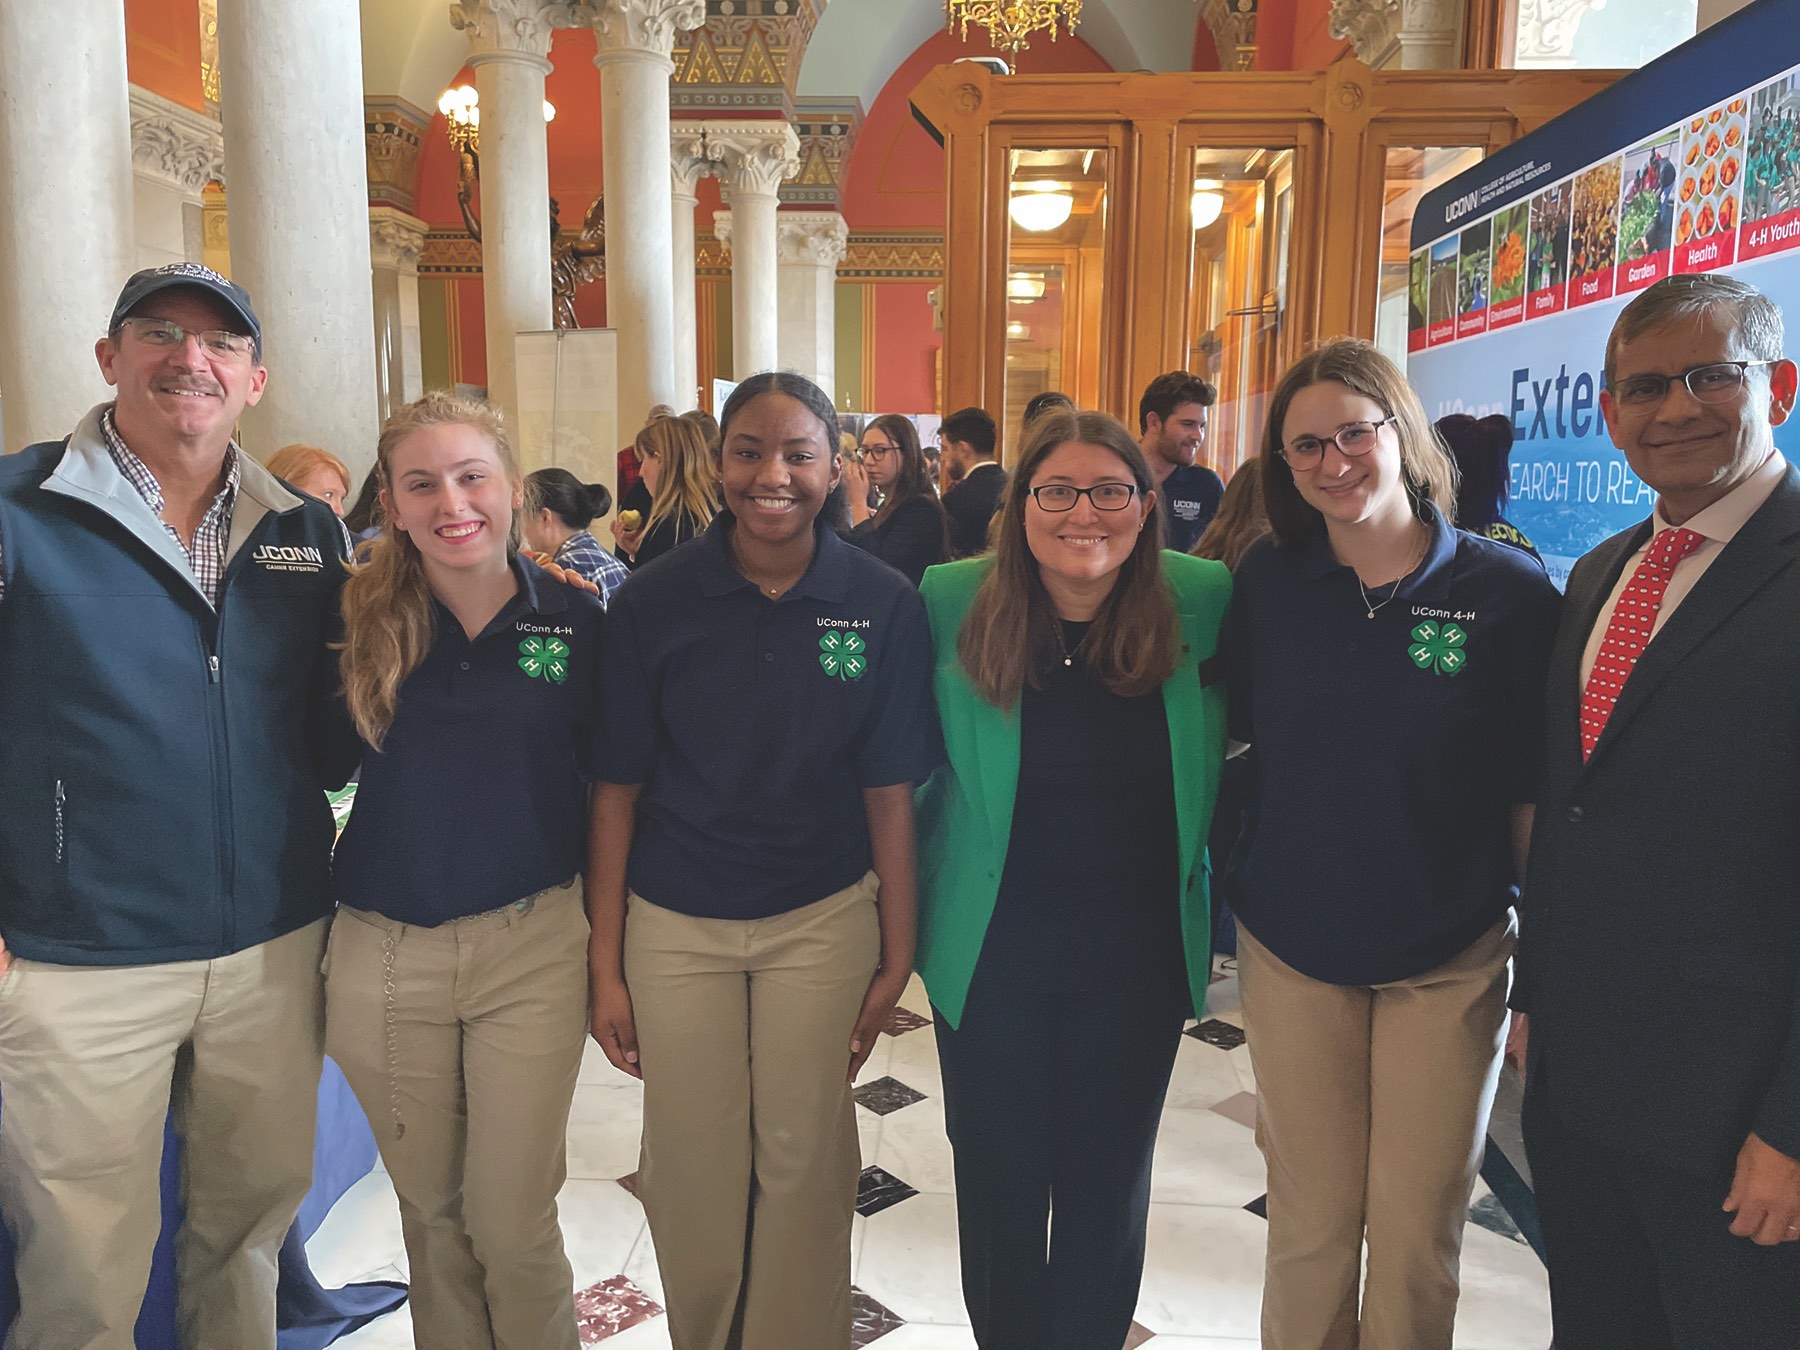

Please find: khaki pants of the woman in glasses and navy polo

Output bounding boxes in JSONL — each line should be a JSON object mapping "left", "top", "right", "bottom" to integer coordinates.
{"left": 1238, "top": 918, "right": 1516, "bottom": 1350}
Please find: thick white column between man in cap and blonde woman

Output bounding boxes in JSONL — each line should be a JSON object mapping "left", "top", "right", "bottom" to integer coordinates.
{"left": 220, "top": 0, "right": 380, "bottom": 463}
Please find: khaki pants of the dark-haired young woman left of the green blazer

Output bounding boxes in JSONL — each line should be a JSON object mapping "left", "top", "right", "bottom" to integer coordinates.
{"left": 625, "top": 873, "right": 880, "bottom": 1350}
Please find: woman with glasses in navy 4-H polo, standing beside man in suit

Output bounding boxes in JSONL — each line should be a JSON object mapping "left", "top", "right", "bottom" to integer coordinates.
{"left": 1224, "top": 338, "right": 1561, "bottom": 1350}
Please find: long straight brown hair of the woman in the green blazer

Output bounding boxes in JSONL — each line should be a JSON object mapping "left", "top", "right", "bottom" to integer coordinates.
{"left": 956, "top": 409, "right": 1181, "bottom": 707}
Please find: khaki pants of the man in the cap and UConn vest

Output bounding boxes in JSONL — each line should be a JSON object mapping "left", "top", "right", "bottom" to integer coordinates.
{"left": 0, "top": 920, "right": 326, "bottom": 1350}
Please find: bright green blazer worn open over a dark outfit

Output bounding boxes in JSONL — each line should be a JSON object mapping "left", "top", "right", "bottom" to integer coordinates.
{"left": 918, "top": 553, "right": 1231, "bottom": 1028}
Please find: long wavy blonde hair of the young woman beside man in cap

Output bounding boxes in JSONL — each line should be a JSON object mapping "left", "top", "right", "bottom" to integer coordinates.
{"left": 338, "top": 389, "right": 520, "bottom": 751}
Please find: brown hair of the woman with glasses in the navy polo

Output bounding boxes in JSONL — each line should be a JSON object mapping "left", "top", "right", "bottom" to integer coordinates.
{"left": 1262, "top": 338, "right": 1456, "bottom": 544}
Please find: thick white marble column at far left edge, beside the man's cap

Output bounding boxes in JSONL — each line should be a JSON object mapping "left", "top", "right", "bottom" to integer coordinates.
{"left": 0, "top": 0, "right": 133, "bottom": 450}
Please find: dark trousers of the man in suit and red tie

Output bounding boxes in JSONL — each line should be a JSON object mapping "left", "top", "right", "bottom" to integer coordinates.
{"left": 1523, "top": 1066, "right": 1800, "bottom": 1350}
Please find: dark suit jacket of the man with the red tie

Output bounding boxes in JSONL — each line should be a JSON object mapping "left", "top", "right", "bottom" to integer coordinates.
{"left": 1514, "top": 468, "right": 1800, "bottom": 1177}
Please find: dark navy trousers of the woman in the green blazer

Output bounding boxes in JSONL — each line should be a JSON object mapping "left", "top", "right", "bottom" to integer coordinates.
{"left": 936, "top": 902, "right": 1186, "bottom": 1350}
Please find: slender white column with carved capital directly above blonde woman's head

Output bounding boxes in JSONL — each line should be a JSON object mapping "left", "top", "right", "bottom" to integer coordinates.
{"left": 450, "top": 0, "right": 574, "bottom": 427}
